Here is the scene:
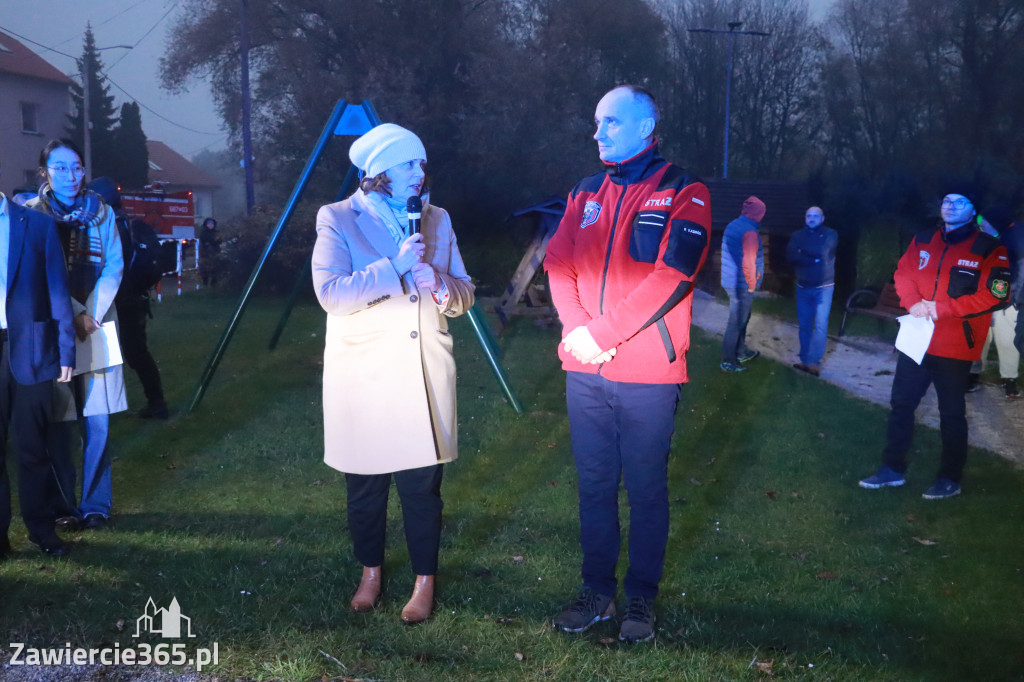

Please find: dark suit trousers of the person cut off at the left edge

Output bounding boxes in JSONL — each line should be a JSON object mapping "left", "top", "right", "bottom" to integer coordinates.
{"left": 0, "top": 339, "right": 55, "bottom": 541}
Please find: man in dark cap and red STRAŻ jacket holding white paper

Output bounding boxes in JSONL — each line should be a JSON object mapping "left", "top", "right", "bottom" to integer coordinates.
{"left": 860, "top": 185, "right": 1010, "bottom": 500}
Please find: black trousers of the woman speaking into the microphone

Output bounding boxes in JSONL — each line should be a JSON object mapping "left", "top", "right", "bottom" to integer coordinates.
{"left": 345, "top": 464, "right": 444, "bottom": 576}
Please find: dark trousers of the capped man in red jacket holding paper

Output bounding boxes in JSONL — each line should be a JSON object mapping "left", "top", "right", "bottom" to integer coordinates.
{"left": 883, "top": 353, "right": 971, "bottom": 483}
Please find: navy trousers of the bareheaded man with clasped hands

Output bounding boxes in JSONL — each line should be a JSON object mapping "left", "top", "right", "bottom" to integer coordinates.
{"left": 565, "top": 372, "right": 680, "bottom": 599}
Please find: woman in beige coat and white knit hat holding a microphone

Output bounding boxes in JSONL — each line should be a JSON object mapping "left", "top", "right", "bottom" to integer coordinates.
{"left": 312, "top": 123, "right": 473, "bottom": 623}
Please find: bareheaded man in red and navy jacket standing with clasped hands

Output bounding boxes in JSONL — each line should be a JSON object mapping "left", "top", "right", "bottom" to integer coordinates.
{"left": 545, "top": 86, "right": 711, "bottom": 642}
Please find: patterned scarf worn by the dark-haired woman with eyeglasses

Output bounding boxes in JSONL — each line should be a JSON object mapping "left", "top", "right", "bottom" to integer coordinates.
{"left": 33, "top": 182, "right": 110, "bottom": 305}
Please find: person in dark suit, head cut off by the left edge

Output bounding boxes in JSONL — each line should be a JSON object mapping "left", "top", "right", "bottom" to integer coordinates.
{"left": 0, "top": 160, "right": 75, "bottom": 558}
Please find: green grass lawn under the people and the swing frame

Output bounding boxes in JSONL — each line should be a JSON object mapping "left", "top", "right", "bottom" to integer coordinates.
{"left": 0, "top": 292, "right": 1024, "bottom": 681}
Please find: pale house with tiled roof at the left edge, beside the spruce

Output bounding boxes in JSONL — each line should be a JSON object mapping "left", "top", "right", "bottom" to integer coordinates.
{"left": 0, "top": 32, "right": 72, "bottom": 197}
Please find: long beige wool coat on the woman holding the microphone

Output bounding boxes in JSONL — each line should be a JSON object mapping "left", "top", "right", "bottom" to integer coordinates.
{"left": 312, "top": 189, "right": 474, "bottom": 474}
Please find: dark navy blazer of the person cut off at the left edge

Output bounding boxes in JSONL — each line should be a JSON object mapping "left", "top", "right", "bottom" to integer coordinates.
{"left": 6, "top": 200, "right": 75, "bottom": 385}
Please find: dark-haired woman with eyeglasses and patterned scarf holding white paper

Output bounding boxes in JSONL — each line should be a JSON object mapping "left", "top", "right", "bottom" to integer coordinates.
{"left": 27, "top": 139, "right": 128, "bottom": 528}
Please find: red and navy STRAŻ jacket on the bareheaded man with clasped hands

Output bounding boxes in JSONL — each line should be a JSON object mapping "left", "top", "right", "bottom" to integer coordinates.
{"left": 545, "top": 142, "right": 711, "bottom": 384}
